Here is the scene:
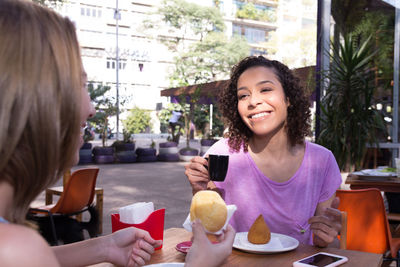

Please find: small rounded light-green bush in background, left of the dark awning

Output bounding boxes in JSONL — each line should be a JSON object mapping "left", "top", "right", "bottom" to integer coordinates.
{"left": 123, "top": 107, "right": 151, "bottom": 134}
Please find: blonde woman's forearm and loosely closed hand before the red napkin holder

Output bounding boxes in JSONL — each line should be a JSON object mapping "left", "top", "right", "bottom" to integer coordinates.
{"left": 53, "top": 227, "right": 161, "bottom": 266}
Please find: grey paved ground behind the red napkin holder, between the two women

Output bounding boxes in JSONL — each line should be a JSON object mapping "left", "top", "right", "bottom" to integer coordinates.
{"left": 34, "top": 162, "right": 192, "bottom": 235}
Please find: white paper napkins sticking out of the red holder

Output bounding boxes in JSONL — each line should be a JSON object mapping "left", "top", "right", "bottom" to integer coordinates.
{"left": 119, "top": 202, "right": 154, "bottom": 224}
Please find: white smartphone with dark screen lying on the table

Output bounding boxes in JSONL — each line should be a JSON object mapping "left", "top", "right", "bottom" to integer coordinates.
{"left": 293, "top": 252, "right": 348, "bottom": 267}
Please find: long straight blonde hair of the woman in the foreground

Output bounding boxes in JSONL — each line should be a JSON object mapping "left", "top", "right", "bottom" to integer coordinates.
{"left": 0, "top": 0, "right": 83, "bottom": 223}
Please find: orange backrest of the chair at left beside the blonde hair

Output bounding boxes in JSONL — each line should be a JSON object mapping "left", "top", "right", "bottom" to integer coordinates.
{"left": 50, "top": 168, "right": 99, "bottom": 214}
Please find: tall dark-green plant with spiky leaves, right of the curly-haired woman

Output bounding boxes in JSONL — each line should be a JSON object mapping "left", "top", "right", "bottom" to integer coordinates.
{"left": 317, "top": 35, "right": 385, "bottom": 170}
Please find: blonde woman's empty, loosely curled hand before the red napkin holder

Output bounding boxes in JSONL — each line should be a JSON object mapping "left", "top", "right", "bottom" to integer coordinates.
{"left": 104, "top": 227, "right": 162, "bottom": 266}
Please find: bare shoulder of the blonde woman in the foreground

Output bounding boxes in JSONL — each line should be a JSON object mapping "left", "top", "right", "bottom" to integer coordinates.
{"left": 0, "top": 224, "right": 59, "bottom": 266}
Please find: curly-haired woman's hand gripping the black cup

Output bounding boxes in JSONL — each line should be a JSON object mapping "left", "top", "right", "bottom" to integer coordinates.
{"left": 185, "top": 156, "right": 210, "bottom": 194}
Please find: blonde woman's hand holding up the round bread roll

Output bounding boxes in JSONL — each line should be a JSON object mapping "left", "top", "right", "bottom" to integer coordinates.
{"left": 185, "top": 219, "right": 235, "bottom": 267}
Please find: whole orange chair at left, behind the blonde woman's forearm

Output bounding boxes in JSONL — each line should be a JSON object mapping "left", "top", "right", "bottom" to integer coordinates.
{"left": 28, "top": 168, "right": 99, "bottom": 244}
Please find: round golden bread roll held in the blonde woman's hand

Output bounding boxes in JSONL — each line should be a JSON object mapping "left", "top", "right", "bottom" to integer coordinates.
{"left": 190, "top": 190, "right": 228, "bottom": 233}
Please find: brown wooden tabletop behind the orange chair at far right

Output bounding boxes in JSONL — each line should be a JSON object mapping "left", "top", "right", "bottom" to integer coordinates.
{"left": 346, "top": 174, "right": 400, "bottom": 193}
